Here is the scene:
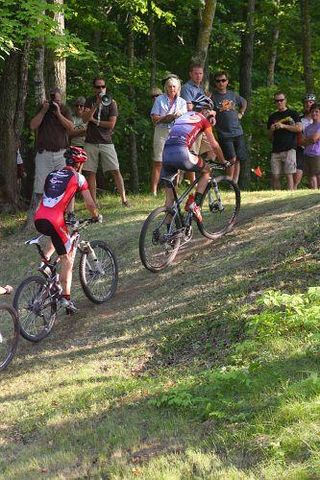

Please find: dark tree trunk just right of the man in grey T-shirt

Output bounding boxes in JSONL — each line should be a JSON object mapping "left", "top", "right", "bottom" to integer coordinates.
{"left": 239, "top": 0, "right": 255, "bottom": 190}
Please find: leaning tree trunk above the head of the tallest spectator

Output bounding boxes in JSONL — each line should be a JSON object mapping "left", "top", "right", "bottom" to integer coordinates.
{"left": 192, "top": 0, "right": 217, "bottom": 66}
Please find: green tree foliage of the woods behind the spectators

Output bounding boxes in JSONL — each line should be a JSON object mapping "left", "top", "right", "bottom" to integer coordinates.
{"left": 0, "top": 0, "right": 320, "bottom": 202}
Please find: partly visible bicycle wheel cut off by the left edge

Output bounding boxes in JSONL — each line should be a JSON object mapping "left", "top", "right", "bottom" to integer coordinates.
{"left": 0, "top": 303, "right": 19, "bottom": 371}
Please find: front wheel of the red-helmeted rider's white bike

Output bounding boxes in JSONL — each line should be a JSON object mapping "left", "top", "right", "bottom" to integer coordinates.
{"left": 79, "top": 240, "right": 118, "bottom": 303}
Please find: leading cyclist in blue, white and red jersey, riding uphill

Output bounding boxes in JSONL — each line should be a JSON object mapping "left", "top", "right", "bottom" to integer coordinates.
{"left": 161, "top": 93, "right": 230, "bottom": 222}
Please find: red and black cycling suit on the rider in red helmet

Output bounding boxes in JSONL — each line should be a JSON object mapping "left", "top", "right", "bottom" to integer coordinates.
{"left": 34, "top": 167, "right": 89, "bottom": 254}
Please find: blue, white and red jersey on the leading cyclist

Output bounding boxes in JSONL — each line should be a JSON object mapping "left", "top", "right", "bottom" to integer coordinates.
{"left": 165, "top": 111, "right": 212, "bottom": 150}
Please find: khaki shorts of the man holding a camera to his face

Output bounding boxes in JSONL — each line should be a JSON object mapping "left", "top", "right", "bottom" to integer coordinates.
{"left": 33, "top": 148, "right": 66, "bottom": 194}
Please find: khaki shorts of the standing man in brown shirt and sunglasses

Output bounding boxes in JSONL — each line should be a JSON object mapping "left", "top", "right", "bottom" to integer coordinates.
{"left": 83, "top": 143, "right": 119, "bottom": 173}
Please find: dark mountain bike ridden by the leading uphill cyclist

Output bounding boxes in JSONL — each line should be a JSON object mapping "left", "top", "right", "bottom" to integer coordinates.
{"left": 139, "top": 162, "right": 240, "bottom": 273}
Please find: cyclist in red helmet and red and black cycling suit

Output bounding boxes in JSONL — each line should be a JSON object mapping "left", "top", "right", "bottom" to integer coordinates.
{"left": 34, "top": 147, "right": 100, "bottom": 311}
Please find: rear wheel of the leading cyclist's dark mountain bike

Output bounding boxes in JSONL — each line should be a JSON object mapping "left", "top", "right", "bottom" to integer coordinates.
{"left": 139, "top": 207, "right": 181, "bottom": 273}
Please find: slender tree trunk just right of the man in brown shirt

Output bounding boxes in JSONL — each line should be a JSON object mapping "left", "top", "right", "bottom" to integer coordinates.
{"left": 128, "top": 14, "right": 139, "bottom": 193}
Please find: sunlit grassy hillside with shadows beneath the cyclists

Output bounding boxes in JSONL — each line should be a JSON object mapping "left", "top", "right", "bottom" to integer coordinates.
{"left": 0, "top": 190, "right": 320, "bottom": 480}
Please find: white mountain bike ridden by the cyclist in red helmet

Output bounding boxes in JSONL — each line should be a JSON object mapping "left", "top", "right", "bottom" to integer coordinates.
{"left": 13, "top": 219, "right": 118, "bottom": 342}
